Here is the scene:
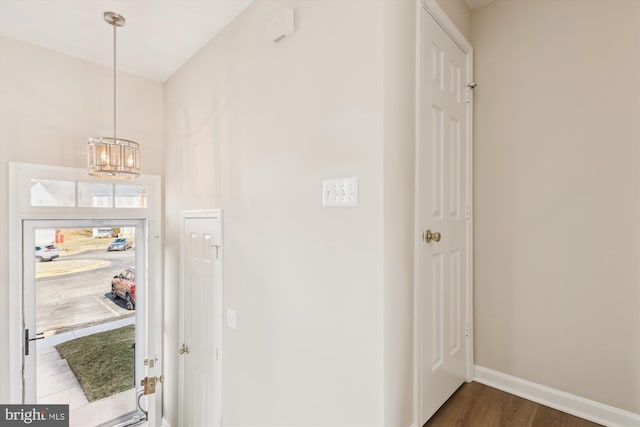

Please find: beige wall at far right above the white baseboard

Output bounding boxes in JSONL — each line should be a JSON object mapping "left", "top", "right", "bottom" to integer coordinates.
{"left": 472, "top": 0, "right": 640, "bottom": 413}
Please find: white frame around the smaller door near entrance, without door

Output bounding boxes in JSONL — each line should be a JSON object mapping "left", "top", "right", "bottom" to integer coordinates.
{"left": 178, "top": 209, "right": 224, "bottom": 427}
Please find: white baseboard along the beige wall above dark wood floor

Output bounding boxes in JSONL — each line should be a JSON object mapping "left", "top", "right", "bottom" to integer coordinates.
{"left": 474, "top": 365, "right": 640, "bottom": 427}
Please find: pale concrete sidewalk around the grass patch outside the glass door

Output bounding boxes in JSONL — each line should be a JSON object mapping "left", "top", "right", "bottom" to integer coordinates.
{"left": 36, "top": 316, "right": 136, "bottom": 427}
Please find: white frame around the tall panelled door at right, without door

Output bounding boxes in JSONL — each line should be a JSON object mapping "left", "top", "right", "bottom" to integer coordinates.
{"left": 413, "top": 0, "right": 474, "bottom": 426}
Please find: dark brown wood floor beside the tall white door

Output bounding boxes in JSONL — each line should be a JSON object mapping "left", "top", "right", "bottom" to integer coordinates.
{"left": 424, "top": 382, "right": 600, "bottom": 427}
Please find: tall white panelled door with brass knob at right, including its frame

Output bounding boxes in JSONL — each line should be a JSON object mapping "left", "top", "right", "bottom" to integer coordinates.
{"left": 415, "top": 0, "right": 472, "bottom": 425}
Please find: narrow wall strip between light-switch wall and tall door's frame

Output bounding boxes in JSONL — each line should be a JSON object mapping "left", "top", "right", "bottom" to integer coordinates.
{"left": 382, "top": 0, "right": 416, "bottom": 427}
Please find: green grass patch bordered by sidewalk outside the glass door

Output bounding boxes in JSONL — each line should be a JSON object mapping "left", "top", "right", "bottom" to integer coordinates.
{"left": 56, "top": 325, "right": 135, "bottom": 402}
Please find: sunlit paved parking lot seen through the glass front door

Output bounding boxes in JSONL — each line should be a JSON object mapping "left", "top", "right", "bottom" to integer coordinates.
{"left": 36, "top": 248, "right": 135, "bottom": 336}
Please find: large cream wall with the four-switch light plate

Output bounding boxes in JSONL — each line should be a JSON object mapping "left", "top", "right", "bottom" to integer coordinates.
{"left": 165, "top": 0, "right": 384, "bottom": 426}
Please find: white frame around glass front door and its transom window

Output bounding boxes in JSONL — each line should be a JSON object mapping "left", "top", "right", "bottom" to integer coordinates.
{"left": 8, "top": 162, "right": 163, "bottom": 427}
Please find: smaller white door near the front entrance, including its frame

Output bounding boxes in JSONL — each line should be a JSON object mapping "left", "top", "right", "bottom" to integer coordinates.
{"left": 177, "top": 210, "right": 222, "bottom": 427}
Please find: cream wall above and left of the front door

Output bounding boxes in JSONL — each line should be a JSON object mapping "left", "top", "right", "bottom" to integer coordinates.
{"left": 0, "top": 36, "right": 164, "bottom": 402}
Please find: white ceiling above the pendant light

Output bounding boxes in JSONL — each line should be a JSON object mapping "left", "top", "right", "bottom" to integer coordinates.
{"left": 0, "top": 0, "right": 253, "bottom": 82}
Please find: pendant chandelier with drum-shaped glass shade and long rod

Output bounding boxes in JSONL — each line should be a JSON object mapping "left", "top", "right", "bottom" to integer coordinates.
{"left": 87, "top": 12, "right": 140, "bottom": 179}
